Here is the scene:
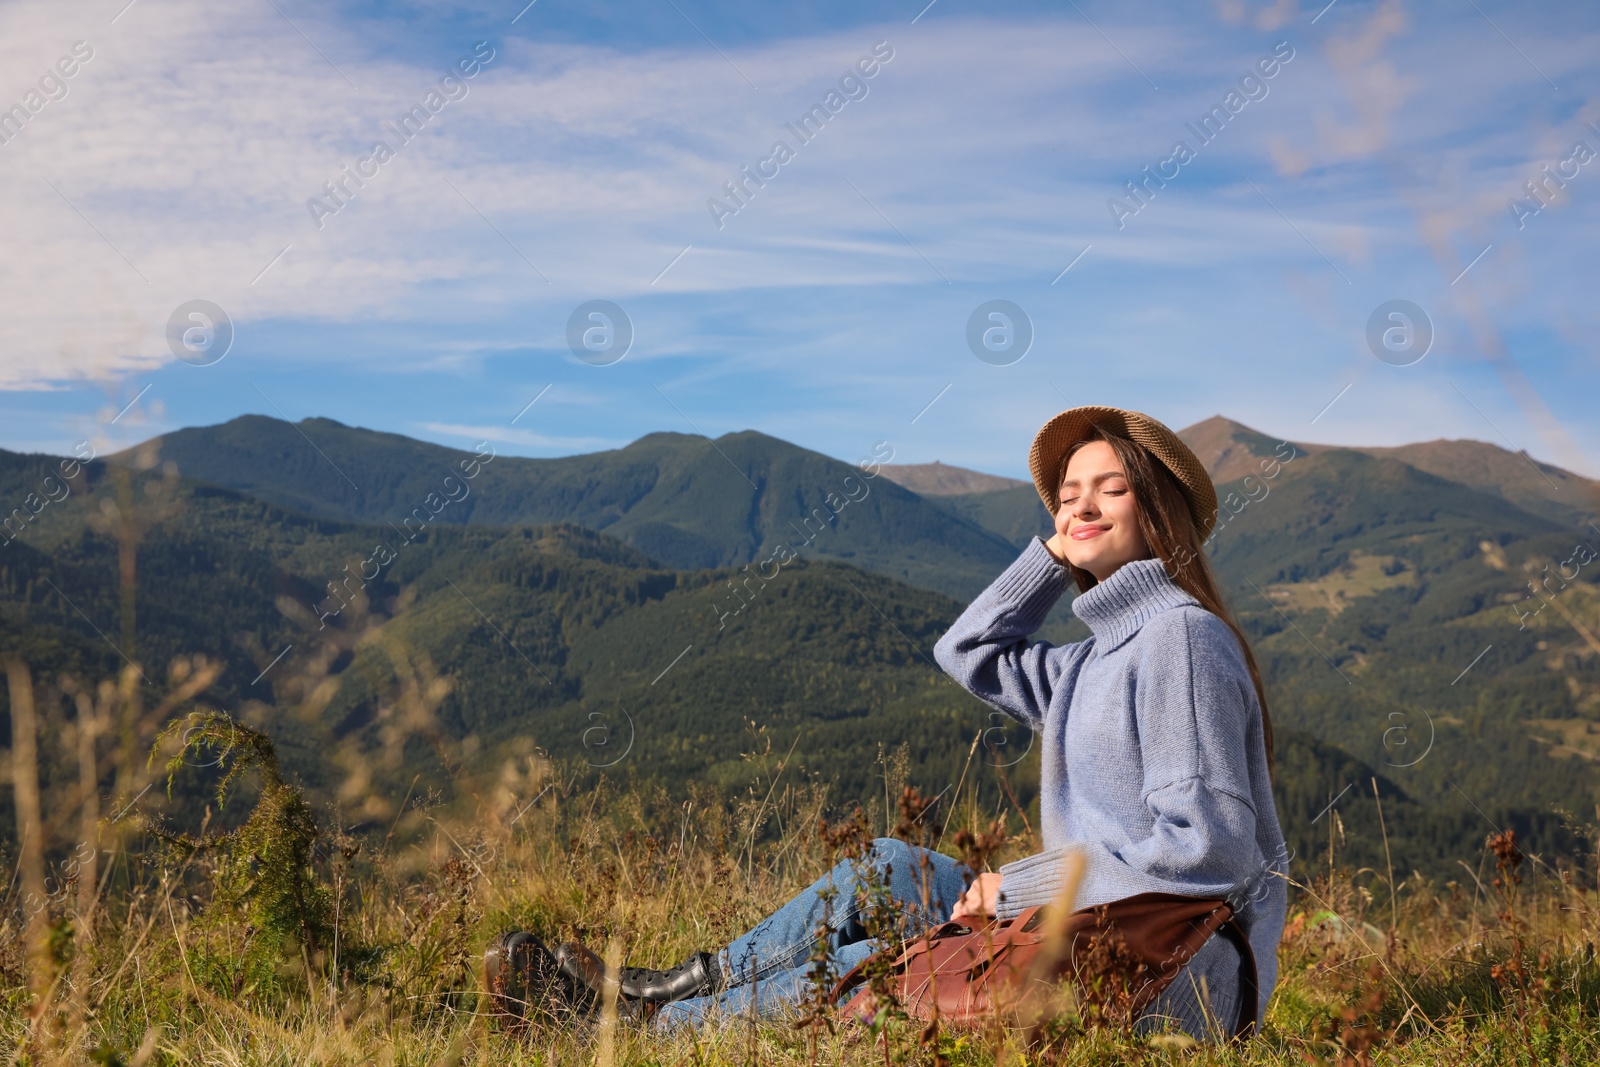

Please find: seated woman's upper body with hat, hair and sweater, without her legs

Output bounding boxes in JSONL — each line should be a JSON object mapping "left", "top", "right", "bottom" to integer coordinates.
{"left": 934, "top": 406, "right": 1288, "bottom": 1037}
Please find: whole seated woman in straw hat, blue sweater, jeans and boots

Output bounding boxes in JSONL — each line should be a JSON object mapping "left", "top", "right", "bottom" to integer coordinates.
{"left": 486, "top": 408, "right": 1286, "bottom": 1040}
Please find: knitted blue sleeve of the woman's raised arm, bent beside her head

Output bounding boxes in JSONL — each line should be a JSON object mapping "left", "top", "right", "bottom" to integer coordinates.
{"left": 933, "top": 537, "right": 1088, "bottom": 731}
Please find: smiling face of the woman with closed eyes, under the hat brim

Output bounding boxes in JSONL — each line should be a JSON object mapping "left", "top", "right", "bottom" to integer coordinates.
{"left": 1056, "top": 442, "right": 1150, "bottom": 582}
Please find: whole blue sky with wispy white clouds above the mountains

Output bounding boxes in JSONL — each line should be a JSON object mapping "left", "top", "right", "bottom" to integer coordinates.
{"left": 0, "top": 0, "right": 1600, "bottom": 477}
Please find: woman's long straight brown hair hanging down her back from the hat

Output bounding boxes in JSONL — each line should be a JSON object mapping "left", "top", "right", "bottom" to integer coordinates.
{"left": 1056, "top": 426, "right": 1272, "bottom": 776}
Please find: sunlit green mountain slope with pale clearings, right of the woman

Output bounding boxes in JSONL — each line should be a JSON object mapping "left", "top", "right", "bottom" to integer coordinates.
{"left": 1213, "top": 451, "right": 1600, "bottom": 811}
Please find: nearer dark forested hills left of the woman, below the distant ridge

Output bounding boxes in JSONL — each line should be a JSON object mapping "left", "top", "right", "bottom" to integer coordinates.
{"left": 0, "top": 453, "right": 1037, "bottom": 827}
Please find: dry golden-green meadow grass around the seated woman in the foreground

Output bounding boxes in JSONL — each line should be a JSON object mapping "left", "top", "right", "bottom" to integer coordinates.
{"left": 9, "top": 735, "right": 1600, "bottom": 1065}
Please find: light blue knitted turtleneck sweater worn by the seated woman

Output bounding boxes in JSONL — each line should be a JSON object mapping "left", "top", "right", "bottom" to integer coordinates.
{"left": 934, "top": 537, "right": 1288, "bottom": 1037}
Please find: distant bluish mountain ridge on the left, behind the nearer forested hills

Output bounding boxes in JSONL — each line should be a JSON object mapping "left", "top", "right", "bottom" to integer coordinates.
{"left": 114, "top": 416, "right": 1013, "bottom": 597}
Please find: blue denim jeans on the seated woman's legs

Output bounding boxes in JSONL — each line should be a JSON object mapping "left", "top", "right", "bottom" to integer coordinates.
{"left": 651, "top": 837, "right": 976, "bottom": 1030}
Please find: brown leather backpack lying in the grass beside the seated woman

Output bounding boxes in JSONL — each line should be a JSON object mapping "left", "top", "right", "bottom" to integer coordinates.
{"left": 834, "top": 893, "right": 1258, "bottom": 1038}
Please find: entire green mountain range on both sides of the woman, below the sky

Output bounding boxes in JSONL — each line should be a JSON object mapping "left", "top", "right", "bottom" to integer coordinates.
{"left": 0, "top": 416, "right": 1600, "bottom": 872}
